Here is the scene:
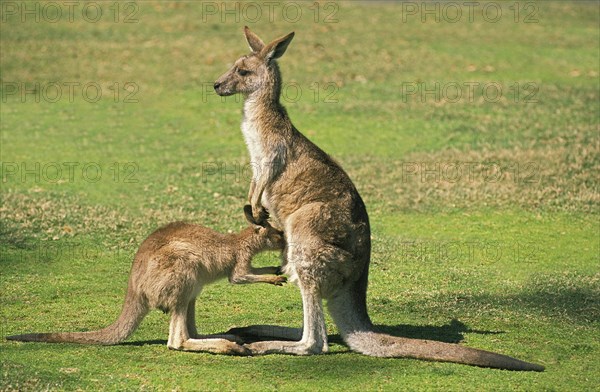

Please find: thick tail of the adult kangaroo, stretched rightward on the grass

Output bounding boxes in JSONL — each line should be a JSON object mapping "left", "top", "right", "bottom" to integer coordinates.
{"left": 328, "top": 279, "right": 544, "bottom": 372}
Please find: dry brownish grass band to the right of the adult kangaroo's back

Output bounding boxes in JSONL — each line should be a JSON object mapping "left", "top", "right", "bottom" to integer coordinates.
{"left": 347, "top": 132, "right": 600, "bottom": 213}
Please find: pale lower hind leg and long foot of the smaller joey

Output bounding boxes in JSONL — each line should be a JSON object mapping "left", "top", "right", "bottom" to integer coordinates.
{"left": 167, "top": 306, "right": 250, "bottom": 355}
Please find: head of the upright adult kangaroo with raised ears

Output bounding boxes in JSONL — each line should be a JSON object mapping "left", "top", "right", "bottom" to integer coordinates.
{"left": 214, "top": 26, "right": 294, "bottom": 96}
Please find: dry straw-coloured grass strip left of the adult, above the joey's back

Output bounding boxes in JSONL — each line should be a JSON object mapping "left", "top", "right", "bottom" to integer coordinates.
{"left": 0, "top": 188, "right": 246, "bottom": 248}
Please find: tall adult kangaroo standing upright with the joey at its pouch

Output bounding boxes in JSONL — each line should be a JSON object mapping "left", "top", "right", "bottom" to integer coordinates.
{"left": 214, "top": 27, "right": 544, "bottom": 371}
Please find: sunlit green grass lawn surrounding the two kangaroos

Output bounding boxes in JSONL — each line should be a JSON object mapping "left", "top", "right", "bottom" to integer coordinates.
{"left": 0, "top": 1, "right": 600, "bottom": 390}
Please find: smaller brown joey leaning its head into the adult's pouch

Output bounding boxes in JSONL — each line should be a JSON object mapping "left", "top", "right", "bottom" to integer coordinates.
{"left": 7, "top": 222, "right": 286, "bottom": 355}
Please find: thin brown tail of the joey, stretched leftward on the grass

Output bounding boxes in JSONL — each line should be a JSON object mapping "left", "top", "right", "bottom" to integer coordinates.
{"left": 6, "top": 292, "right": 148, "bottom": 345}
